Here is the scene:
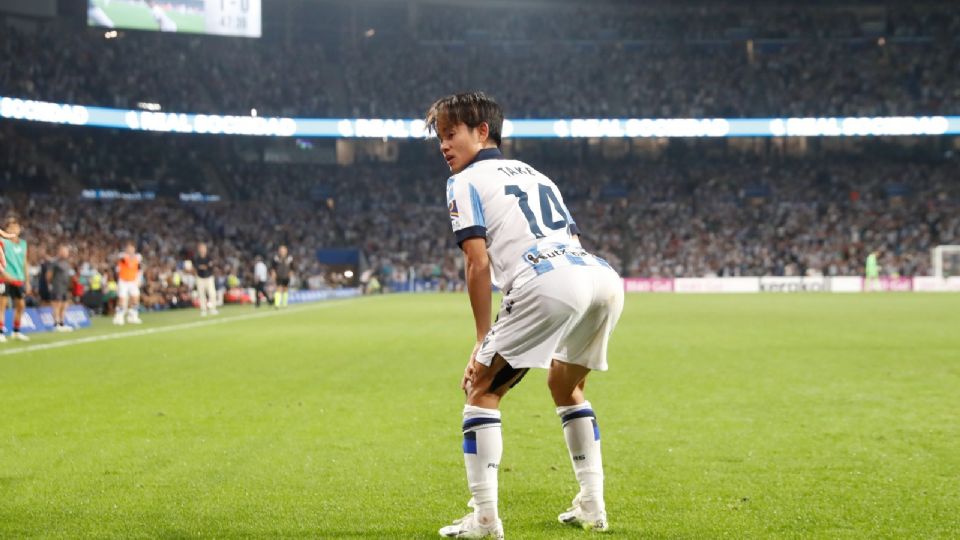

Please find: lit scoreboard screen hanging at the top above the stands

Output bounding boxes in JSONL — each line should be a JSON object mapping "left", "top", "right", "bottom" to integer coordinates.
{"left": 87, "top": 0, "right": 261, "bottom": 37}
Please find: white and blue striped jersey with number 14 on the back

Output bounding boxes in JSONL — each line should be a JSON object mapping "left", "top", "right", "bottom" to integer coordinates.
{"left": 447, "top": 148, "right": 607, "bottom": 290}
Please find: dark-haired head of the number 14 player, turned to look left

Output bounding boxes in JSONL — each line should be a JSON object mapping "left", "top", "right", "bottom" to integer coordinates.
{"left": 425, "top": 92, "right": 503, "bottom": 174}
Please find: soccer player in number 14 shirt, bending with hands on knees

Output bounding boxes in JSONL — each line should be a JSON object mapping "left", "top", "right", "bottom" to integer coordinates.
{"left": 426, "top": 92, "right": 623, "bottom": 538}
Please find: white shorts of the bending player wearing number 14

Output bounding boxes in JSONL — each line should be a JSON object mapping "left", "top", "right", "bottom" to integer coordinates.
{"left": 477, "top": 266, "right": 623, "bottom": 371}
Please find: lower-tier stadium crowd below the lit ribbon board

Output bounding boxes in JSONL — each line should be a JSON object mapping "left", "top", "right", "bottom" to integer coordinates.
{"left": 0, "top": 121, "right": 960, "bottom": 296}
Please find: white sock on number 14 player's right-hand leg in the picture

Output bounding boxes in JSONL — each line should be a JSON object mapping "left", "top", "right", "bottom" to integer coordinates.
{"left": 557, "top": 401, "right": 604, "bottom": 512}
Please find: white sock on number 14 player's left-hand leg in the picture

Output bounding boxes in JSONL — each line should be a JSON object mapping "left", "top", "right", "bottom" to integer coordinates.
{"left": 463, "top": 405, "right": 503, "bottom": 525}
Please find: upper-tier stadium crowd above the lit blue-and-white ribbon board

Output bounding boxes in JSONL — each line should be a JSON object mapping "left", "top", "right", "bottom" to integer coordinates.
{"left": 0, "top": 3, "right": 960, "bottom": 118}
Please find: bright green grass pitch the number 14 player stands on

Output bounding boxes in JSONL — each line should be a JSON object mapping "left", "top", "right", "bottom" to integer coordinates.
{"left": 0, "top": 294, "right": 960, "bottom": 539}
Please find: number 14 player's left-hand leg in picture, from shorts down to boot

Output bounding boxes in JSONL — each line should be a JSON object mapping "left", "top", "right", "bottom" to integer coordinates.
{"left": 440, "top": 354, "right": 527, "bottom": 538}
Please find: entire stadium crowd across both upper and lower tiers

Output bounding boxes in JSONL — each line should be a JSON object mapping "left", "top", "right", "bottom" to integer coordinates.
{"left": 0, "top": 2, "right": 960, "bottom": 312}
